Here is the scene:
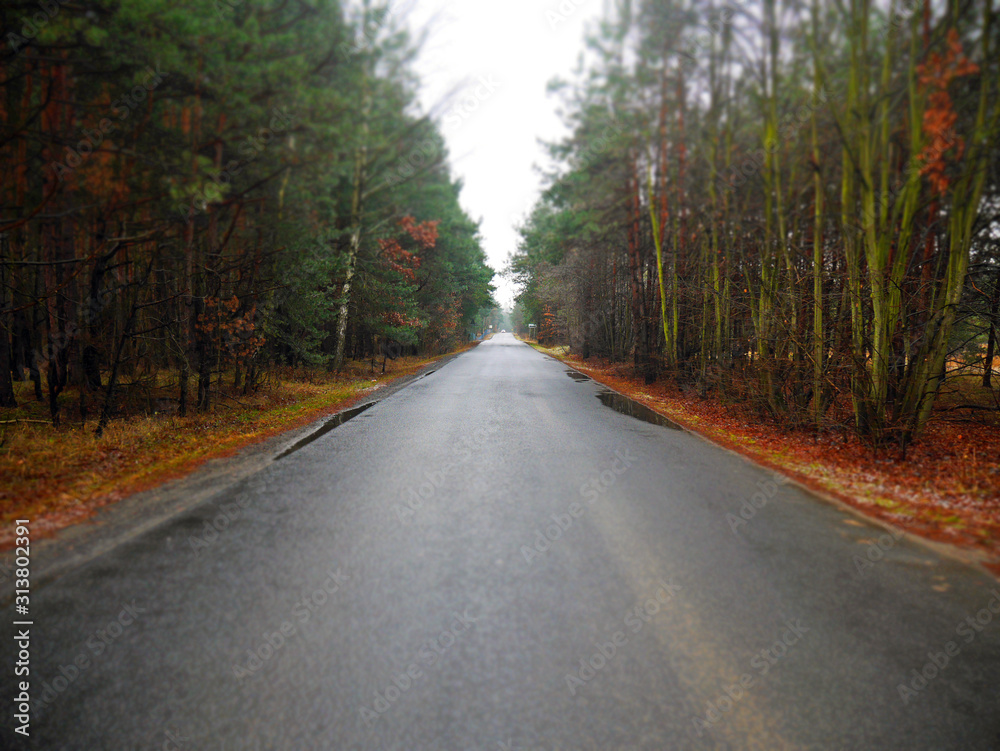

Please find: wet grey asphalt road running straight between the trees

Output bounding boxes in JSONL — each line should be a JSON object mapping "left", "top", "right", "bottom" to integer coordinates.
{"left": 0, "top": 334, "right": 1000, "bottom": 751}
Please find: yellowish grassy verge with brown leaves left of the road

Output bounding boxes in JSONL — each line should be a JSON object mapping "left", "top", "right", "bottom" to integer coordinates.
{"left": 0, "top": 345, "right": 474, "bottom": 549}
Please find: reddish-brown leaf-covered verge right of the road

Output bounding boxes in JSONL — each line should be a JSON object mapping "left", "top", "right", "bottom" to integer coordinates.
{"left": 533, "top": 345, "right": 1000, "bottom": 574}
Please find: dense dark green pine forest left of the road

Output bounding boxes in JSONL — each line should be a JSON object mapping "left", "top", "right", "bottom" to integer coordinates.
{"left": 0, "top": 0, "right": 495, "bottom": 434}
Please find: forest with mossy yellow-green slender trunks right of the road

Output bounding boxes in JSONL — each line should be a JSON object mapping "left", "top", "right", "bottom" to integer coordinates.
{"left": 507, "top": 0, "right": 1000, "bottom": 450}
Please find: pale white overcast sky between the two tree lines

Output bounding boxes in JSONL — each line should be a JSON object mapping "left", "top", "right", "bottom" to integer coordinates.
{"left": 400, "top": 0, "right": 604, "bottom": 309}
